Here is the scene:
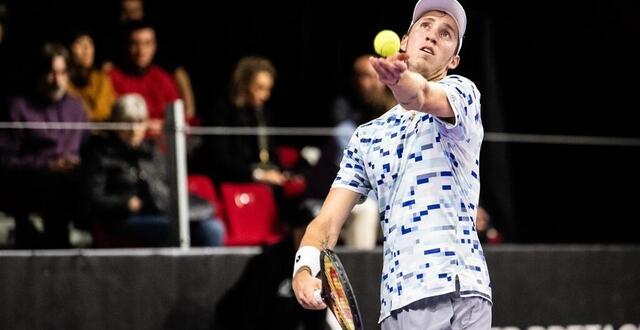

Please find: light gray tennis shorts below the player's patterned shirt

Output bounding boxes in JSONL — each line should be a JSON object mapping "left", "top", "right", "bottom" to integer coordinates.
{"left": 381, "top": 293, "right": 491, "bottom": 330}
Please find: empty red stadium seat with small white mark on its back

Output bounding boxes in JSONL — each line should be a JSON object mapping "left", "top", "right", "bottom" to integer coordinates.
{"left": 220, "top": 183, "right": 284, "bottom": 246}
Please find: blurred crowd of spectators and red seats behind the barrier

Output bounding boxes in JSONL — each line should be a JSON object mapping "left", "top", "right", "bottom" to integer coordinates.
{"left": 0, "top": 0, "right": 500, "bottom": 250}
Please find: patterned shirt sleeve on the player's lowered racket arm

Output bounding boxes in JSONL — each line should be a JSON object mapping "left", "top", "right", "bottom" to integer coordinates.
{"left": 331, "top": 129, "right": 371, "bottom": 204}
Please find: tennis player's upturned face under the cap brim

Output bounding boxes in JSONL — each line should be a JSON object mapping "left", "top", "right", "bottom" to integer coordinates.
{"left": 402, "top": 10, "right": 460, "bottom": 80}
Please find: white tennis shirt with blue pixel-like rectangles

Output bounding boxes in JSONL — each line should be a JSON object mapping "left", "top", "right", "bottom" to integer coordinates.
{"left": 332, "top": 75, "right": 491, "bottom": 322}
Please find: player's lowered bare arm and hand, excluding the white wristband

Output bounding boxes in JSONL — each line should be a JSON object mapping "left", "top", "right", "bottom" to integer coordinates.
{"left": 291, "top": 188, "right": 360, "bottom": 309}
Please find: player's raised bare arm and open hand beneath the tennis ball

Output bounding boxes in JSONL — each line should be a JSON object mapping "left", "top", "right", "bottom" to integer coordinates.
{"left": 369, "top": 53, "right": 454, "bottom": 119}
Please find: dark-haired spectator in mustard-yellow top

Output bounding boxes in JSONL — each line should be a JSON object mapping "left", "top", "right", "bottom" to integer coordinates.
{"left": 69, "top": 32, "right": 116, "bottom": 121}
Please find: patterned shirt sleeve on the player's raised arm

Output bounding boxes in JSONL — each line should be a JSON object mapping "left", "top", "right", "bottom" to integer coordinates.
{"left": 436, "top": 75, "right": 482, "bottom": 140}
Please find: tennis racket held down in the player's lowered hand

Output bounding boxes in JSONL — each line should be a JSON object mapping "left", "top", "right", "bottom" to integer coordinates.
{"left": 315, "top": 249, "right": 362, "bottom": 330}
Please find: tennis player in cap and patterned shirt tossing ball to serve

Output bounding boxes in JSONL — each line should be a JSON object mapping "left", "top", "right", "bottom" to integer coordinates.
{"left": 292, "top": 0, "right": 492, "bottom": 329}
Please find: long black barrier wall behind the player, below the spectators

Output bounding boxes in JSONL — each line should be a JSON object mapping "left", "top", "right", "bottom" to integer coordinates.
{"left": 0, "top": 245, "right": 640, "bottom": 330}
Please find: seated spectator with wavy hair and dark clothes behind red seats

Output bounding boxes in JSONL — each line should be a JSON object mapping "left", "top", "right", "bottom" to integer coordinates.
{"left": 192, "top": 56, "right": 306, "bottom": 227}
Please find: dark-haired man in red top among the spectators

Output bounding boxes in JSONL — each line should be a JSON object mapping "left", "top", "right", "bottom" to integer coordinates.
{"left": 110, "top": 21, "right": 181, "bottom": 136}
